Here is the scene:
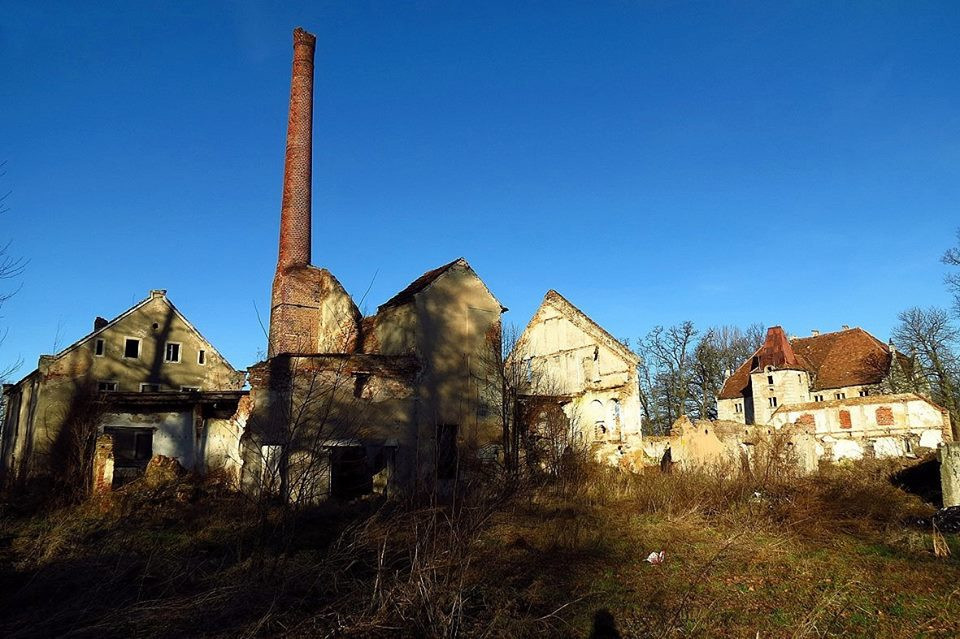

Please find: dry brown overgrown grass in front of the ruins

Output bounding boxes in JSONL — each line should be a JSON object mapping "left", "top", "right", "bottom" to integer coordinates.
{"left": 0, "top": 456, "right": 960, "bottom": 637}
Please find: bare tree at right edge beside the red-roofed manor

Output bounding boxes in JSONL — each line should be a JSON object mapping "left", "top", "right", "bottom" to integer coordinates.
{"left": 893, "top": 307, "right": 960, "bottom": 437}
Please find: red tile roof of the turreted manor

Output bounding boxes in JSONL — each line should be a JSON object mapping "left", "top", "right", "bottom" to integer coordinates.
{"left": 718, "top": 327, "right": 890, "bottom": 399}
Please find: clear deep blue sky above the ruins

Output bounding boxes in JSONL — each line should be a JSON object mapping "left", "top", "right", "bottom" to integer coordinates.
{"left": 0, "top": 1, "right": 960, "bottom": 372}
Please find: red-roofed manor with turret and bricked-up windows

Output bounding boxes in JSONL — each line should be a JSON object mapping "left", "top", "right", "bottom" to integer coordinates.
{"left": 717, "top": 326, "right": 951, "bottom": 460}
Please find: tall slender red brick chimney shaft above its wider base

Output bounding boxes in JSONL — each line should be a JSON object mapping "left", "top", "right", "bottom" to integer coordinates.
{"left": 277, "top": 27, "right": 317, "bottom": 272}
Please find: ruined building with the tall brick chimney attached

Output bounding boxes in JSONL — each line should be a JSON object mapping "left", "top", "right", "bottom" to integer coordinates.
{"left": 243, "top": 29, "right": 506, "bottom": 501}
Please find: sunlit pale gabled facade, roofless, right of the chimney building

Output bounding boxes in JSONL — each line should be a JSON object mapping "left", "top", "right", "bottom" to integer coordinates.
{"left": 510, "top": 290, "right": 641, "bottom": 462}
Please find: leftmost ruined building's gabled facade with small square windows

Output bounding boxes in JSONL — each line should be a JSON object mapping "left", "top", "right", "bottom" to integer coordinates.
{"left": 0, "top": 290, "right": 244, "bottom": 478}
